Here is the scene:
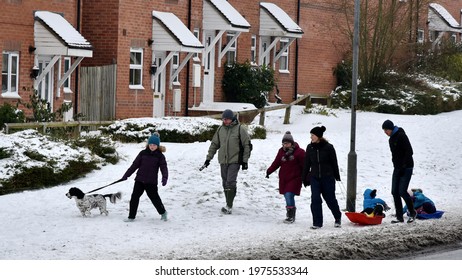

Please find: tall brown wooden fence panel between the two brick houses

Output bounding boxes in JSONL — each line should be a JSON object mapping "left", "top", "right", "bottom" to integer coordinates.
{"left": 79, "top": 64, "right": 117, "bottom": 121}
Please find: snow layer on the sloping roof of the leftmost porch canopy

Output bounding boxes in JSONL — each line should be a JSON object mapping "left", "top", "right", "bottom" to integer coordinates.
{"left": 35, "top": 11, "right": 92, "bottom": 49}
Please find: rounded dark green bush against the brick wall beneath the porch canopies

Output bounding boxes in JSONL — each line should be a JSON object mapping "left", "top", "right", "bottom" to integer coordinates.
{"left": 222, "top": 61, "right": 276, "bottom": 108}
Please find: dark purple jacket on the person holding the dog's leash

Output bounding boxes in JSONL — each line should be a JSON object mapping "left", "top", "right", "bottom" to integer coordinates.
{"left": 122, "top": 146, "right": 168, "bottom": 186}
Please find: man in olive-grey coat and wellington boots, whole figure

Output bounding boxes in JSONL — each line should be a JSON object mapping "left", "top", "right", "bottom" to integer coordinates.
{"left": 204, "top": 109, "right": 250, "bottom": 214}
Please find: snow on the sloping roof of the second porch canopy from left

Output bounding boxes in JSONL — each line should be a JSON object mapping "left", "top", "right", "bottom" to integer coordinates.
{"left": 152, "top": 11, "right": 204, "bottom": 48}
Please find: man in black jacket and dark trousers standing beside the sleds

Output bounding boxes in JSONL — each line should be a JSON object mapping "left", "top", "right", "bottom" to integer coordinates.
{"left": 382, "top": 120, "right": 417, "bottom": 223}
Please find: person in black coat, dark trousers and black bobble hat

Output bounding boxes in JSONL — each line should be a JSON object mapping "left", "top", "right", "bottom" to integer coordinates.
{"left": 302, "top": 126, "right": 342, "bottom": 229}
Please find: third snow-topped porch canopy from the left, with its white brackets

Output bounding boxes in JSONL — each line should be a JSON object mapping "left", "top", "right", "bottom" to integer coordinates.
{"left": 202, "top": 0, "right": 250, "bottom": 67}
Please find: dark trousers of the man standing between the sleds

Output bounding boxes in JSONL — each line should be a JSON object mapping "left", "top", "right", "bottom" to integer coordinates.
{"left": 391, "top": 168, "right": 415, "bottom": 221}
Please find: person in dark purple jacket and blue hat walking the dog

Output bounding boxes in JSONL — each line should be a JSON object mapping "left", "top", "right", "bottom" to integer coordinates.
{"left": 122, "top": 134, "right": 168, "bottom": 222}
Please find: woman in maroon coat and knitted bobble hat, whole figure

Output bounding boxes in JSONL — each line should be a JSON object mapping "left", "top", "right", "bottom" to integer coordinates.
{"left": 266, "top": 131, "right": 305, "bottom": 224}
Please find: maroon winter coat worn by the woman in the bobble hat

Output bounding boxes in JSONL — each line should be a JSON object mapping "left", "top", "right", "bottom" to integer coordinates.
{"left": 266, "top": 143, "right": 305, "bottom": 195}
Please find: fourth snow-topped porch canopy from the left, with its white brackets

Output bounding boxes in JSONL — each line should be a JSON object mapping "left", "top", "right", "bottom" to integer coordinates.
{"left": 258, "top": 2, "right": 303, "bottom": 65}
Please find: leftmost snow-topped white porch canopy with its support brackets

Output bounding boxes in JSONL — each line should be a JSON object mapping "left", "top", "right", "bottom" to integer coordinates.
{"left": 34, "top": 11, "right": 93, "bottom": 90}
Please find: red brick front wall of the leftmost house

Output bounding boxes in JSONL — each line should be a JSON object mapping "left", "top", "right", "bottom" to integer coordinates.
{"left": 0, "top": 0, "right": 77, "bottom": 117}
